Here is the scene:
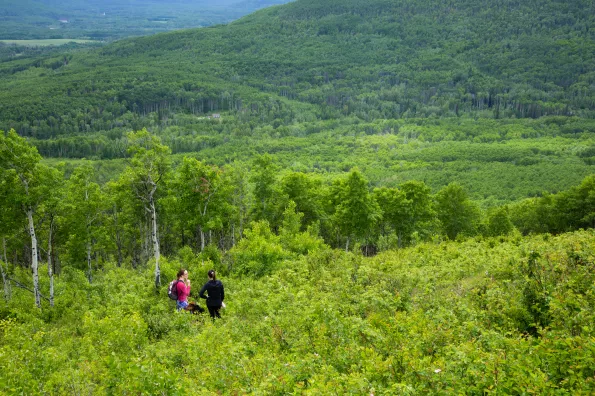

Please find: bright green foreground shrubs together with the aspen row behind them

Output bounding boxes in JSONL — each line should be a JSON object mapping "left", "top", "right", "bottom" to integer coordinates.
{"left": 0, "top": 130, "right": 595, "bottom": 395}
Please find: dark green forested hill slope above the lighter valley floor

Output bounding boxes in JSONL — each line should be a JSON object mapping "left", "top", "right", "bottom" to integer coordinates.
{"left": 0, "top": 0, "right": 595, "bottom": 138}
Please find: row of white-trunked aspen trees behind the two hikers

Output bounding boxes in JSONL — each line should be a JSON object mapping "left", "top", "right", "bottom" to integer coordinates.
{"left": 0, "top": 126, "right": 595, "bottom": 276}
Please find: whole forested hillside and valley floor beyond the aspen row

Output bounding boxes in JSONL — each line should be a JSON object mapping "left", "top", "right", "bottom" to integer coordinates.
{"left": 0, "top": 0, "right": 595, "bottom": 204}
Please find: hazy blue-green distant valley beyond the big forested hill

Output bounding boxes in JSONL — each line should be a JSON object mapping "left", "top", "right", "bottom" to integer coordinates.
{"left": 0, "top": 0, "right": 287, "bottom": 41}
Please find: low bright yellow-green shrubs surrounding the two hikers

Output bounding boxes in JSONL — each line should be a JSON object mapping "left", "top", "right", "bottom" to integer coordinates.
{"left": 0, "top": 230, "right": 595, "bottom": 395}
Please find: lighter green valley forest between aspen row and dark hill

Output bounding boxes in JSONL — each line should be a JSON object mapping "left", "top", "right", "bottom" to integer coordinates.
{"left": 30, "top": 116, "right": 595, "bottom": 206}
